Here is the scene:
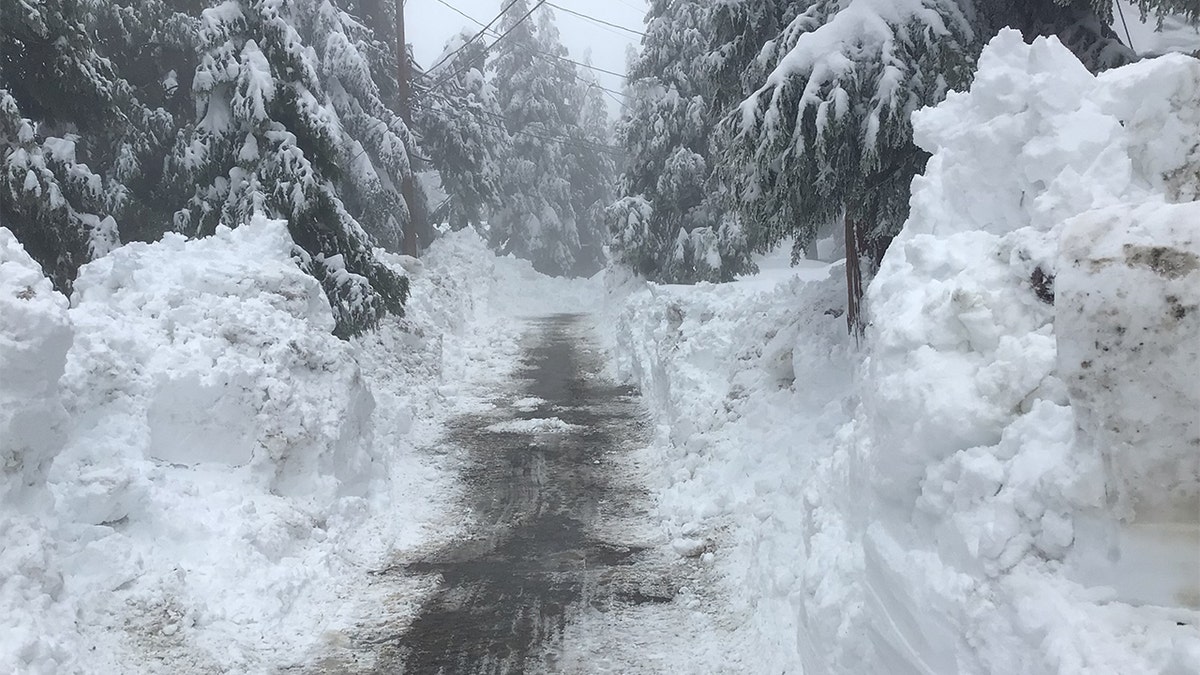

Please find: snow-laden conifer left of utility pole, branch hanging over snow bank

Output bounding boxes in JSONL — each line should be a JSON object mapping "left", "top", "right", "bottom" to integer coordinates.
{"left": 168, "top": 0, "right": 413, "bottom": 336}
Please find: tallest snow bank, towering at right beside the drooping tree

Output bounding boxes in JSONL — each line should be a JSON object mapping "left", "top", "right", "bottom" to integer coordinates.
{"left": 859, "top": 31, "right": 1200, "bottom": 673}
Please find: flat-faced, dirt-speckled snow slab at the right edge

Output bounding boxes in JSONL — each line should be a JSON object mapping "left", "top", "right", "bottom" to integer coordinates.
{"left": 1055, "top": 202, "right": 1200, "bottom": 520}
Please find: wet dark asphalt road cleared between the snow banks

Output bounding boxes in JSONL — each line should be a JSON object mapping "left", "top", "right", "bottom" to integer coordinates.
{"left": 372, "top": 315, "right": 671, "bottom": 675}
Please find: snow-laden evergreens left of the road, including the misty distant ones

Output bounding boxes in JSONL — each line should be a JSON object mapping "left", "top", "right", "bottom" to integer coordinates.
{"left": 0, "top": 0, "right": 616, "bottom": 336}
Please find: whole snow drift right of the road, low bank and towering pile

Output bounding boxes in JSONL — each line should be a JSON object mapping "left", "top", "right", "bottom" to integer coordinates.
{"left": 612, "top": 31, "right": 1200, "bottom": 673}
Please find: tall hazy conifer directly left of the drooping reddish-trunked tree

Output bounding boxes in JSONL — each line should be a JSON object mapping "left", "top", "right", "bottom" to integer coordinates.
{"left": 608, "top": 0, "right": 792, "bottom": 282}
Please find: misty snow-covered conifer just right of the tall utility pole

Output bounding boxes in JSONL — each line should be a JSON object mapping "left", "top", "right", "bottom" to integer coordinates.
{"left": 414, "top": 31, "right": 509, "bottom": 229}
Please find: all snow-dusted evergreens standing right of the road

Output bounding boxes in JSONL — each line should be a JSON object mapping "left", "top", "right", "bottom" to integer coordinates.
{"left": 608, "top": 0, "right": 1200, "bottom": 333}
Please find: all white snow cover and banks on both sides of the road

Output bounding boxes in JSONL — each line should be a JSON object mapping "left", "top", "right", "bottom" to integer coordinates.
{"left": 0, "top": 23, "right": 1200, "bottom": 674}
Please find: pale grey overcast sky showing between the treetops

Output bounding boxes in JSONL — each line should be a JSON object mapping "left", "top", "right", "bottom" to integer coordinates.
{"left": 407, "top": 0, "right": 646, "bottom": 115}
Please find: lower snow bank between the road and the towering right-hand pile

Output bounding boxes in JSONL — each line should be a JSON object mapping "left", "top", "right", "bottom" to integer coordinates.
{"left": 610, "top": 260, "right": 860, "bottom": 673}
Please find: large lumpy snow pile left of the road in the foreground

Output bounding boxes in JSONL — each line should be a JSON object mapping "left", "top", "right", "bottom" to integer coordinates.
{"left": 0, "top": 220, "right": 386, "bottom": 673}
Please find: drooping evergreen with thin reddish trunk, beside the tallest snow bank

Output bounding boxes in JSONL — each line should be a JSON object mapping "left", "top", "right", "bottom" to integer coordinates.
{"left": 721, "top": 0, "right": 1154, "bottom": 333}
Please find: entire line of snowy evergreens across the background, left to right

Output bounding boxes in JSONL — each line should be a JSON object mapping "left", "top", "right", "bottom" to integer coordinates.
{"left": 0, "top": 0, "right": 1200, "bottom": 336}
